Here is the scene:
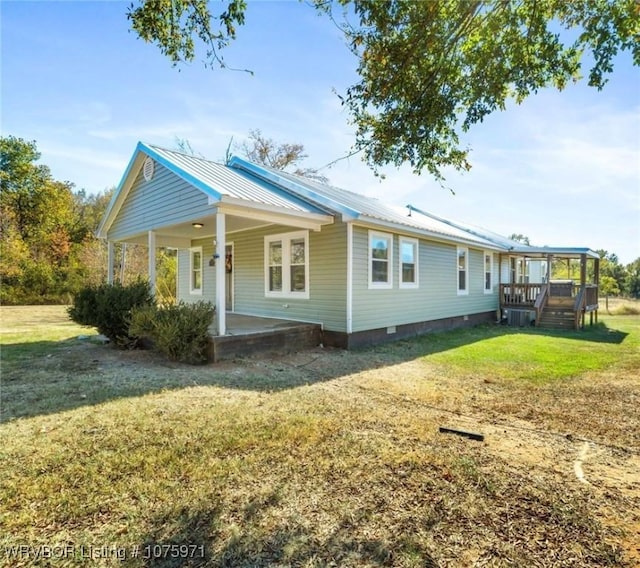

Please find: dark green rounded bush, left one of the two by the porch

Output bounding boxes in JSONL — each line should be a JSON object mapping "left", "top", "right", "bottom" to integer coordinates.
{"left": 69, "top": 279, "right": 154, "bottom": 347}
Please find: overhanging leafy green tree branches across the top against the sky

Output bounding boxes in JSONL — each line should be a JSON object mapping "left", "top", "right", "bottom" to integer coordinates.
{"left": 128, "top": 0, "right": 640, "bottom": 179}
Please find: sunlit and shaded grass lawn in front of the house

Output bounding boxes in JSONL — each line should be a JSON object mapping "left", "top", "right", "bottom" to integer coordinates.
{"left": 0, "top": 308, "right": 640, "bottom": 567}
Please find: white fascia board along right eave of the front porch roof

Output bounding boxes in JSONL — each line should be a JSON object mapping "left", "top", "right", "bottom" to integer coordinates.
{"left": 215, "top": 195, "right": 334, "bottom": 231}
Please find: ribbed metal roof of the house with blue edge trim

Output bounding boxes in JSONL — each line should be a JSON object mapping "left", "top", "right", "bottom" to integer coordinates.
{"left": 100, "top": 142, "right": 598, "bottom": 257}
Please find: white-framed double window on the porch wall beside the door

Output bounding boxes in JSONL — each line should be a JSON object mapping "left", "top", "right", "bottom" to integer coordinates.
{"left": 264, "top": 231, "right": 309, "bottom": 299}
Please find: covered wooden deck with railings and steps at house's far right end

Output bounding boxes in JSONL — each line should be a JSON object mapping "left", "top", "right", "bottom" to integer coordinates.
{"left": 499, "top": 247, "right": 600, "bottom": 329}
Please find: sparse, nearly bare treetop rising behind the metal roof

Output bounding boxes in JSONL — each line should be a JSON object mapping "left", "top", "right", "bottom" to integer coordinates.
{"left": 239, "top": 129, "right": 328, "bottom": 183}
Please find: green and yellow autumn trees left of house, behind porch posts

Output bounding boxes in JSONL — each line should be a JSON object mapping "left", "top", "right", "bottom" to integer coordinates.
{"left": 0, "top": 136, "right": 176, "bottom": 305}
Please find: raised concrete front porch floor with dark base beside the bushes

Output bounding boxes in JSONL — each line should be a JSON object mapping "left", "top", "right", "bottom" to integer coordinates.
{"left": 209, "top": 313, "right": 322, "bottom": 363}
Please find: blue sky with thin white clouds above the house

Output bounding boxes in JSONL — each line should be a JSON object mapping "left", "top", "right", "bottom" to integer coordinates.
{"left": 0, "top": 0, "right": 640, "bottom": 263}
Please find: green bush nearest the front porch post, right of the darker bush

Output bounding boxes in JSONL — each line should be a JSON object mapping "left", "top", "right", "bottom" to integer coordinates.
{"left": 130, "top": 301, "right": 214, "bottom": 364}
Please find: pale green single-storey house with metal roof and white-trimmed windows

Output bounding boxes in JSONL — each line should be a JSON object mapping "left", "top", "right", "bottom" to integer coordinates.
{"left": 98, "top": 143, "right": 598, "bottom": 356}
